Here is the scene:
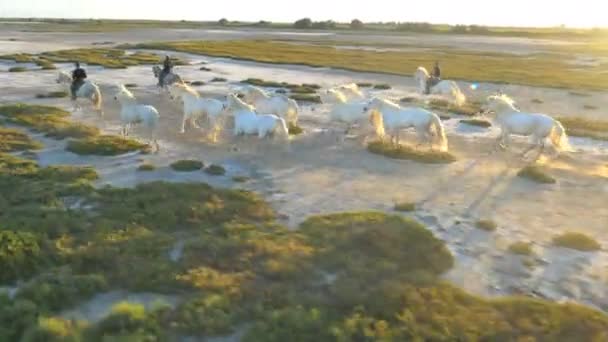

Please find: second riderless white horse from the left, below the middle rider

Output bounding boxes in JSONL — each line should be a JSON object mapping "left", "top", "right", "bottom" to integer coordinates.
{"left": 169, "top": 83, "right": 226, "bottom": 141}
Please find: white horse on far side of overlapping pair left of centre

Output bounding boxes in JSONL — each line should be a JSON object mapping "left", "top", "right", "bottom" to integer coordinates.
{"left": 237, "top": 85, "right": 300, "bottom": 125}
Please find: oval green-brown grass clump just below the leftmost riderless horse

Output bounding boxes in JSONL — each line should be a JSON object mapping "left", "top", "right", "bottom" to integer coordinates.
{"left": 66, "top": 135, "right": 151, "bottom": 156}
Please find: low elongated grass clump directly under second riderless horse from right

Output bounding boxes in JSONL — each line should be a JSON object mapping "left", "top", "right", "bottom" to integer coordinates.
{"left": 367, "top": 140, "right": 456, "bottom": 164}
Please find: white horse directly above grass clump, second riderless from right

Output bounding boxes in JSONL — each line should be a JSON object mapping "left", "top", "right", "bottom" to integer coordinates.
{"left": 364, "top": 98, "right": 448, "bottom": 151}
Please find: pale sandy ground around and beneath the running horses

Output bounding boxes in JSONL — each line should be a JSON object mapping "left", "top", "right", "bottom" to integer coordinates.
{"left": 0, "top": 32, "right": 608, "bottom": 318}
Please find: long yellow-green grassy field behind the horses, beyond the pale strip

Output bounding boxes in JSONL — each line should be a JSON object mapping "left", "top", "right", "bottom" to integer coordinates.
{"left": 122, "top": 41, "right": 608, "bottom": 90}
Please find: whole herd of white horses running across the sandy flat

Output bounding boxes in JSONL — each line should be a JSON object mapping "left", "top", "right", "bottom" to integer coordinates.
{"left": 57, "top": 67, "right": 569, "bottom": 155}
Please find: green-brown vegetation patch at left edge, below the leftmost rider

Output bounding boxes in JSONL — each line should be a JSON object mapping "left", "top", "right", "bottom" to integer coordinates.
{"left": 0, "top": 104, "right": 99, "bottom": 139}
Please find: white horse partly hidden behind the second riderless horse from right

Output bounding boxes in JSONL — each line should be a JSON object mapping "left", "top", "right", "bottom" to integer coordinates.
{"left": 321, "top": 89, "right": 367, "bottom": 134}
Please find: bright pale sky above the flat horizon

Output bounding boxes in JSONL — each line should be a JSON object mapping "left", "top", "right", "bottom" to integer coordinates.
{"left": 0, "top": 0, "right": 608, "bottom": 27}
